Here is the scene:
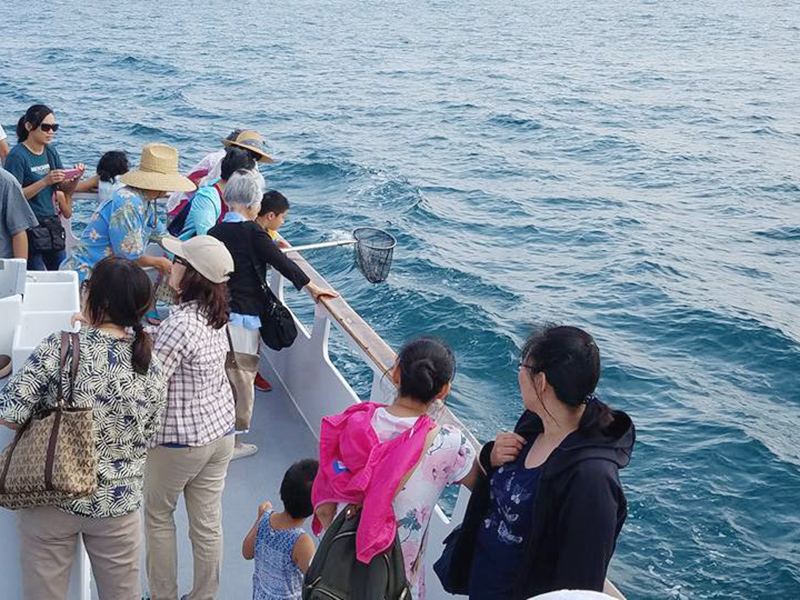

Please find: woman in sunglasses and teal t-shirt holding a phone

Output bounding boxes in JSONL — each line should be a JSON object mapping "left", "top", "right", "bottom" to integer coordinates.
{"left": 5, "top": 104, "right": 85, "bottom": 271}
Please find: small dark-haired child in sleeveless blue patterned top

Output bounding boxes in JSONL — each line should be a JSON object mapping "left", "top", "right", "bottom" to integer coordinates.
{"left": 242, "top": 459, "right": 319, "bottom": 600}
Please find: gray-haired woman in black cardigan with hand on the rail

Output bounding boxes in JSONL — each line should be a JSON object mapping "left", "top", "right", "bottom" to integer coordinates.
{"left": 208, "top": 169, "right": 338, "bottom": 458}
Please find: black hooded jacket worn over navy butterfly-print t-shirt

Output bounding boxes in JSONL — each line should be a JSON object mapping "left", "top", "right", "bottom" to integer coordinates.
{"left": 449, "top": 400, "right": 636, "bottom": 600}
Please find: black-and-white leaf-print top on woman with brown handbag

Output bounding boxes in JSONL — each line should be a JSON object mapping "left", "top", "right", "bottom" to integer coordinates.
{"left": 0, "top": 327, "right": 167, "bottom": 518}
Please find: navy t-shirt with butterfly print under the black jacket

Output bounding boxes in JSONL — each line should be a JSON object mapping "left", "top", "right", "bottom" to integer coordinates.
{"left": 469, "top": 442, "right": 542, "bottom": 600}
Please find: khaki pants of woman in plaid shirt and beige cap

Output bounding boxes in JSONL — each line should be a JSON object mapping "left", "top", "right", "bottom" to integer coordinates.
{"left": 144, "top": 435, "right": 233, "bottom": 600}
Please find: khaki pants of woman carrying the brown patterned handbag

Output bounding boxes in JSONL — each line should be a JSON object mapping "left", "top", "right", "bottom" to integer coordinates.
{"left": 18, "top": 506, "right": 142, "bottom": 600}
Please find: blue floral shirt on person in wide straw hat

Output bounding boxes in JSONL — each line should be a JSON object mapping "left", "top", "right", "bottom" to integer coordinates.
{"left": 61, "top": 186, "right": 164, "bottom": 281}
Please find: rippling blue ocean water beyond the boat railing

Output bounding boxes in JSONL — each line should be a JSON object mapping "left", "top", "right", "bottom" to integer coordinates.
{"left": 0, "top": 0, "right": 800, "bottom": 599}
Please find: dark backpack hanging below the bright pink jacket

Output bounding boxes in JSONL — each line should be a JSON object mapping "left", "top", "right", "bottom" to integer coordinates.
{"left": 303, "top": 505, "right": 411, "bottom": 600}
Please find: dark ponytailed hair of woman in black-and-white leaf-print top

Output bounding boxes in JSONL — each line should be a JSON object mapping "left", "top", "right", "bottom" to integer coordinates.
{"left": 85, "top": 256, "right": 153, "bottom": 375}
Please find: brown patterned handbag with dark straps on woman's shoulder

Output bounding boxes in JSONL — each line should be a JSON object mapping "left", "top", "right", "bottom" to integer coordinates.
{"left": 0, "top": 332, "right": 97, "bottom": 510}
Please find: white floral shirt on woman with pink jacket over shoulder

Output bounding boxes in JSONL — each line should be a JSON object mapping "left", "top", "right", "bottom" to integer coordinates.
{"left": 372, "top": 408, "right": 475, "bottom": 600}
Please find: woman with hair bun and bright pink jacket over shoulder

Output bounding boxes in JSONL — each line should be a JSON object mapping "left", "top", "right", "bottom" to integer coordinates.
{"left": 312, "top": 338, "right": 477, "bottom": 600}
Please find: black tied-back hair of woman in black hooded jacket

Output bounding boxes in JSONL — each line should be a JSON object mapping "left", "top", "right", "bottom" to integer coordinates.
{"left": 521, "top": 325, "right": 613, "bottom": 433}
